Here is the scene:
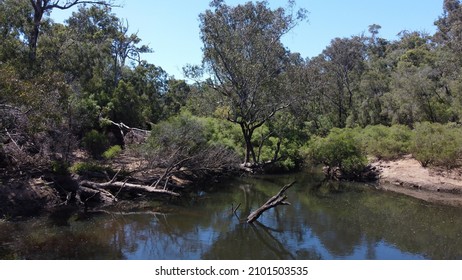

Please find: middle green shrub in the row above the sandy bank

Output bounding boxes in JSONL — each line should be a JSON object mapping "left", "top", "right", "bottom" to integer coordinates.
{"left": 359, "top": 125, "right": 412, "bottom": 160}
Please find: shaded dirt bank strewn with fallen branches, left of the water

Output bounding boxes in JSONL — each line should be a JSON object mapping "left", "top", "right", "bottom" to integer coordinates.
{"left": 0, "top": 150, "right": 224, "bottom": 220}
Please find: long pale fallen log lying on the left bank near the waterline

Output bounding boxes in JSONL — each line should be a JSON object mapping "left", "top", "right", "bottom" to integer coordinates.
{"left": 80, "top": 180, "right": 180, "bottom": 197}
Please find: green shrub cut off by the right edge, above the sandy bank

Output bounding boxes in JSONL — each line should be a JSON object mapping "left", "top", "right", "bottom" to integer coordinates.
{"left": 411, "top": 122, "right": 462, "bottom": 168}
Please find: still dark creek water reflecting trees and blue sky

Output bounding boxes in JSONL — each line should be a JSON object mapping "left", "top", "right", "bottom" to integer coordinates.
{"left": 0, "top": 172, "right": 462, "bottom": 260}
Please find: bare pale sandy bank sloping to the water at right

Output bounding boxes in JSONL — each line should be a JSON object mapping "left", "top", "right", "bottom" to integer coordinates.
{"left": 372, "top": 155, "right": 462, "bottom": 207}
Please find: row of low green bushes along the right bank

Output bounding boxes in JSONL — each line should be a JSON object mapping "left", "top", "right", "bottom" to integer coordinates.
{"left": 304, "top": 122, "right": 462, "bottom": 173}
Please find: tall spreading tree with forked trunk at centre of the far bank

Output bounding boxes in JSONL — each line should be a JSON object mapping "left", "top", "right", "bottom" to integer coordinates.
{"left": 196, "top": 0, "right": 306, "bottom": 164}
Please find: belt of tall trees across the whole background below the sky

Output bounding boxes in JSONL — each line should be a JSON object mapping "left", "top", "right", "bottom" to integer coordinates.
{"left": 0, "top": 0, "right": 462, "bottom": 173}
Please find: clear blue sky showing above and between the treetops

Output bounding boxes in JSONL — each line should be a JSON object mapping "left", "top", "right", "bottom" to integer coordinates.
{"left": 51, "top": 0, "right": 443, "bottom": 79}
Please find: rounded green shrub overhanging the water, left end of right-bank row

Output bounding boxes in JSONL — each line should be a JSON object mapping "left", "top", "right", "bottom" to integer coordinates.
{"left": 305, "top": 128, "right": 367, "bottom": 175}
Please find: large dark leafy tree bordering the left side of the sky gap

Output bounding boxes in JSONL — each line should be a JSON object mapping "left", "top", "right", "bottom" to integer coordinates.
{"left": 61, "top": 5, "right": 159, "bottom": 127}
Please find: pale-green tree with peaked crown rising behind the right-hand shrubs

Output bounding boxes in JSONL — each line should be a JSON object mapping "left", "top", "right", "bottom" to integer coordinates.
{"left": 383, "top": 32, "right": 452, "bottom": 125}
